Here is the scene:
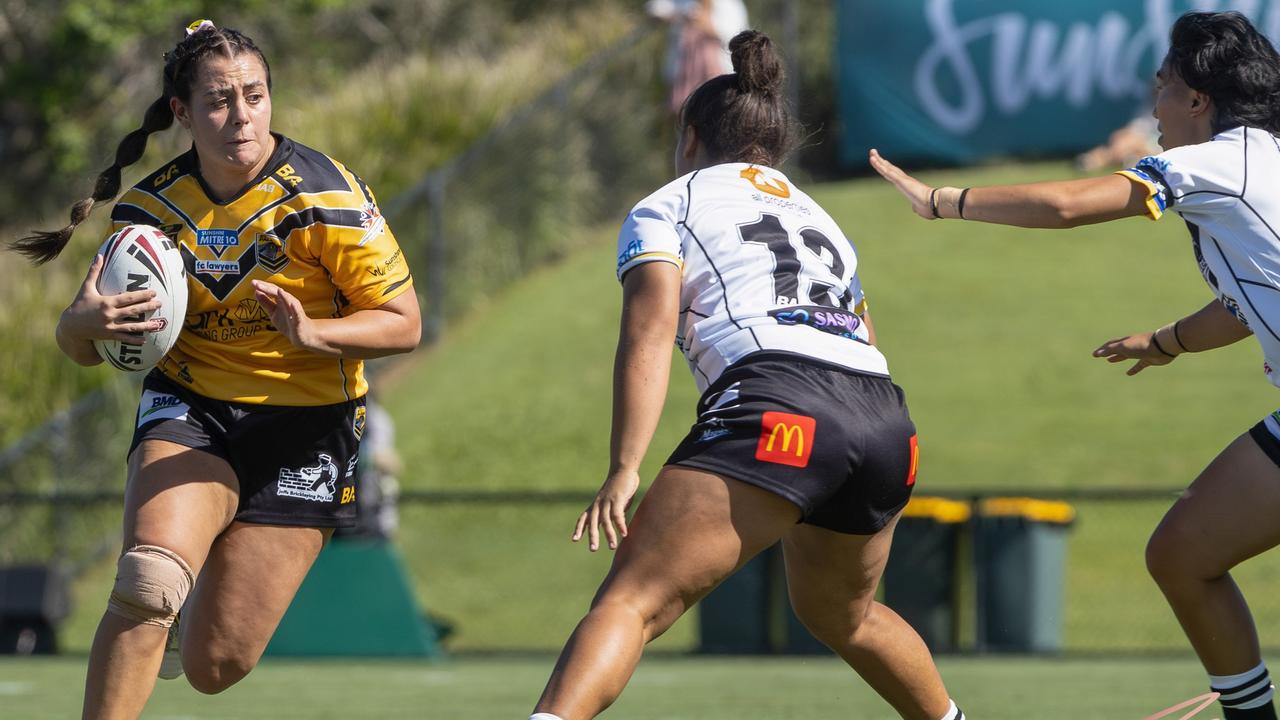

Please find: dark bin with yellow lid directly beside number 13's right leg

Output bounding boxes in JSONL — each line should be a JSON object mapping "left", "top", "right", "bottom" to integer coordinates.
{"left": 883, "top": 496, "right": 972, "bottom": 652}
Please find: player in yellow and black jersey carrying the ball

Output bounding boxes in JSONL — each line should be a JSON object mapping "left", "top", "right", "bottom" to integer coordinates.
{"left": 15, "top": 20, "right": 420, "bottom": 719}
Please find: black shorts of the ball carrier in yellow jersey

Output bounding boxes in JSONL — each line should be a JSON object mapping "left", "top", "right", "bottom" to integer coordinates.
{"left": 129, "top": 370, "right": 365, "bottom": 528}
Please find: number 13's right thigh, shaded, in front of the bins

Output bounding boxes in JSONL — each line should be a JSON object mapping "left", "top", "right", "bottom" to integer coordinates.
{"left": 782, "top": 515, "right": 900, "bottom": 625}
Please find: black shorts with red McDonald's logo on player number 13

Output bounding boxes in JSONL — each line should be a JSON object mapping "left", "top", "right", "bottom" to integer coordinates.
{"left": 667, "top": 352, "right": 916, "bottom": 534}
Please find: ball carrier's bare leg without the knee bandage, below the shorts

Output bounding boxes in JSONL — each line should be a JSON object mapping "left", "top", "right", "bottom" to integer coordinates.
{"left": 182, "top": 521, "right": 338, "bottom": 674}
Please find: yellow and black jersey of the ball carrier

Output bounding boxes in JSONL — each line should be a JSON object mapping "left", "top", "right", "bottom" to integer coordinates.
{"left": 111, "top": 136, "right": 411, "bottom": 405}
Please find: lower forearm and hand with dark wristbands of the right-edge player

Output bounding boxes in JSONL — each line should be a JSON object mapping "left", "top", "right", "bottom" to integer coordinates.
{"left": 1093, "top": 300, "right": 1253, "bottom": 375}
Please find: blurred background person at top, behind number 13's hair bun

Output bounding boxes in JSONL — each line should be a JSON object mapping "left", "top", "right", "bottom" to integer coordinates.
{"left": 645, "top": 0, "right": 748, "bottom": 115}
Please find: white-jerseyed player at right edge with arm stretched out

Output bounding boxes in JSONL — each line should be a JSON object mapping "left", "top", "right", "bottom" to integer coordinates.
{"left": 870, "top": 12, "right": 1280, "bottom": 720}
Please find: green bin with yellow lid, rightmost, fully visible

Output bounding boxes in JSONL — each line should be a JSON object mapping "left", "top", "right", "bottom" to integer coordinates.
{"left": 974, "top": 497, "right": 1075, "bottom": 653}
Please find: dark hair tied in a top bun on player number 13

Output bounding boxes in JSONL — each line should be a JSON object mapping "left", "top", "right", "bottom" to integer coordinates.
{"left": 680, "top": 29, "right": 797, "bottom": 167}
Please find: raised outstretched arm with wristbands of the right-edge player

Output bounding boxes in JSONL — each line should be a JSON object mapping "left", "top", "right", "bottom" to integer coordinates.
{"left": 870, "top": 150, "right": 1149, "bottom": 228}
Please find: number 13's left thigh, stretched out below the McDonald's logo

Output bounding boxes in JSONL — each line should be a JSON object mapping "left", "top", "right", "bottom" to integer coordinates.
{"left": 596, "top": 465, "right": 800, "bottom": 609}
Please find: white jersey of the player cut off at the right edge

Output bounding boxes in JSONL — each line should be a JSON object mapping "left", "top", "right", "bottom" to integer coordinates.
{"left": 1120, "top": 127, "right": 1280, "bottom": 386}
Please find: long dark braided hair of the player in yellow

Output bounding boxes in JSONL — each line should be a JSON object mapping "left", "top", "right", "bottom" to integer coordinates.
{"left": 9, "top": 20, "right": 271, "bottom": 265}
